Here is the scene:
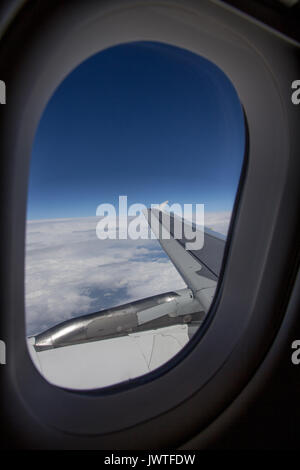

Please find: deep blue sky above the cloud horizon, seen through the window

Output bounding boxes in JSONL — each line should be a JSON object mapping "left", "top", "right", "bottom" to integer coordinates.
{"left": 27, "top": 42, "right": 245, "bottom": 220}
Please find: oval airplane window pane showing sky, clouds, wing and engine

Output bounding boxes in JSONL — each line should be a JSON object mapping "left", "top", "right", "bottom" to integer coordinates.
{"left": 25, "top": 42, "right": 245, "bottom": 389}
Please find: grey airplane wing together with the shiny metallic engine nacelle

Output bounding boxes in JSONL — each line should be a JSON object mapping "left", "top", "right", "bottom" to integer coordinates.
{"left": 28, "top": 206, "right": 225, "bottom": 389}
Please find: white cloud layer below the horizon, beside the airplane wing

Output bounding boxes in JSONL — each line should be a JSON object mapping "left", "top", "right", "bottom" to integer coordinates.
{"left": 25, "top": 212, "right": 230, "bottom": 335}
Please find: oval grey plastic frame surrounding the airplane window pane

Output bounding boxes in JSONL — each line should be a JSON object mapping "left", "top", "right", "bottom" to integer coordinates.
{"left": 2, "top": 1, "right": 296, "bottom": 444}
